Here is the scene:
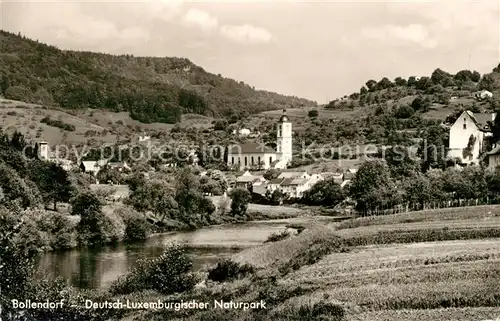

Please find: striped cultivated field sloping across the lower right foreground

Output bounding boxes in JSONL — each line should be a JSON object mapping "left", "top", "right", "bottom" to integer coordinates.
{"left": 235, "top": 206, "right": 500, "bottom": 321}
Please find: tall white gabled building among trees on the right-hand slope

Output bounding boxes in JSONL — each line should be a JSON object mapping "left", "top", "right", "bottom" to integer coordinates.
{"left": 447, "top": 111, "right": 496, "bottom": 164}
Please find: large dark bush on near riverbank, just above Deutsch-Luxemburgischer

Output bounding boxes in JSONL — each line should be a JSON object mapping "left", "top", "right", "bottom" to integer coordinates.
{"left": 110, "top": 245, "right": 197, "bottom": 294}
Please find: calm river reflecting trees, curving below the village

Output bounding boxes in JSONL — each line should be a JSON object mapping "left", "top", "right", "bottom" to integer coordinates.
{"left": 37, "top": 220, "right": 298, "bottom": 289}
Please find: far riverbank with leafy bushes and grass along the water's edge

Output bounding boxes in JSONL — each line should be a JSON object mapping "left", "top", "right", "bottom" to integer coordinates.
{"left": 24, "top": 202, "right": 314, "bottom": 252}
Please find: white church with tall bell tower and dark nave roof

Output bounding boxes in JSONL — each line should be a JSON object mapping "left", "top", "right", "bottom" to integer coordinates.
{"left": 227, "top": 110, "right": 292, "bottom": 170}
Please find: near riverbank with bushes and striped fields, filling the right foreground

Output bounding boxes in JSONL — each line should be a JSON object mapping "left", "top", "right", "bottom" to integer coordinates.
{"left": 13, "top": 207, "right": 500, "bottom": 321}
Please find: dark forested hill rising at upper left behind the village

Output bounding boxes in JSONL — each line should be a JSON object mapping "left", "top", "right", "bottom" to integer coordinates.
{"left": 0, "top": 30, "right": 316, "bottom": 123}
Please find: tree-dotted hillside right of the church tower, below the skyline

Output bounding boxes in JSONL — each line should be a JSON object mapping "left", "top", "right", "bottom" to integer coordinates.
{"left": 247, "top": 65, "right": 500, "bottom": 149}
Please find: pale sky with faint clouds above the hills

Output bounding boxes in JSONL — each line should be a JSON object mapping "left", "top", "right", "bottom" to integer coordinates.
{"left": 0, "top": 0, "right": 500, "bottom": 103}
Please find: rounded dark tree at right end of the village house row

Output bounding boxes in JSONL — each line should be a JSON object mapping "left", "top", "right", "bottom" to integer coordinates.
{"left": 303, "top": 178, "right": 345, "bottom": 207}
